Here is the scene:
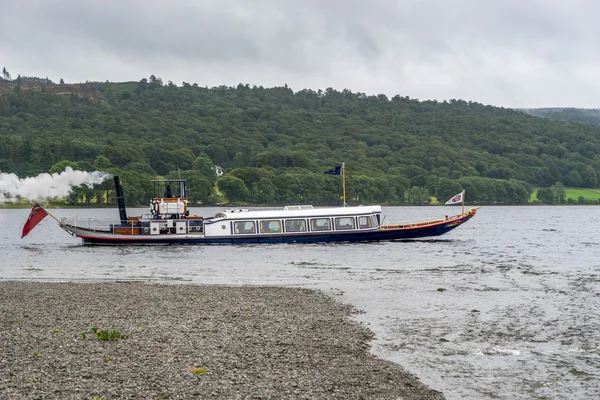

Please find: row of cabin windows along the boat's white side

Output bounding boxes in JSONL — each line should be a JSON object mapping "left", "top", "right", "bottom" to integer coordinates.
{"left": 233, "top": 216, "right": 377, "bottom": 234}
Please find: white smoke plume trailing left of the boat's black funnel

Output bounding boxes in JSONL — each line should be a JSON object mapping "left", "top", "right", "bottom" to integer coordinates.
{"left": 0, "top": 167, "right": 111, "bottom": 203}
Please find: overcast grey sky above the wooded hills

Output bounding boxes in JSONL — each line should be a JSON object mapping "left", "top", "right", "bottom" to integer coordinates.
{"left": 0, "top": 0, "right": 600, "bottom": 108}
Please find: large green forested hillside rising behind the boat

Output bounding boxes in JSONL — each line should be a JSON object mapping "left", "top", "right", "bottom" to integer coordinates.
{"left": 0, "top": 76, "right": 600, "bottom": 204}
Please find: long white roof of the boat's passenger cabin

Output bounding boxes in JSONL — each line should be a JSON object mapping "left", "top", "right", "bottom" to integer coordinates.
{"left": 214, "top": 206, "right": 381, "bottom": 220}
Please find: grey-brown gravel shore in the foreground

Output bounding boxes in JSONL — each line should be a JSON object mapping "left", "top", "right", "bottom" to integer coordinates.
{"left": 0, "top": 281, "right": 444, "bottom": 400}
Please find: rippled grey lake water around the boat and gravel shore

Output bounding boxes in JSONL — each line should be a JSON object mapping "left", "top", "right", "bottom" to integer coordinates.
{"left": 0, "top": 206, "right": 600, "bottom": 399}
